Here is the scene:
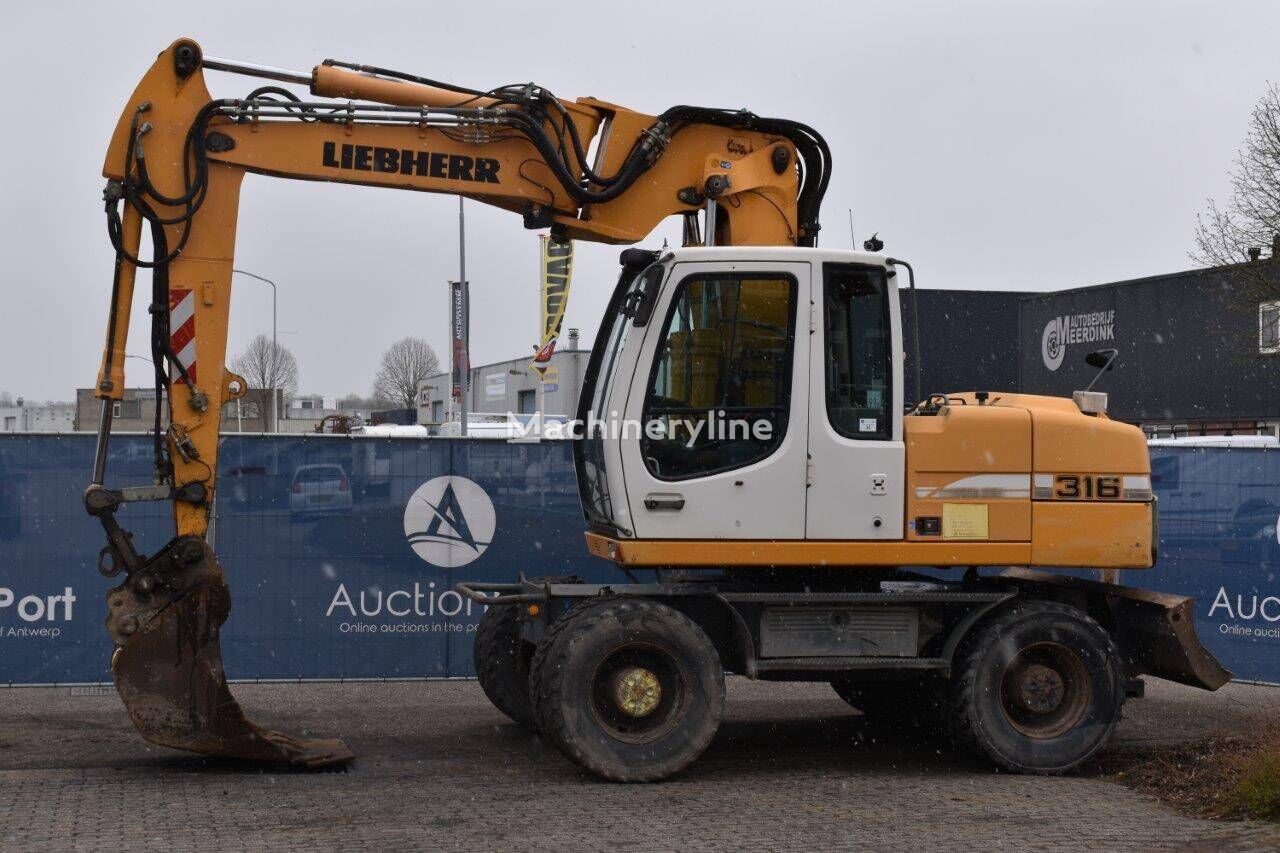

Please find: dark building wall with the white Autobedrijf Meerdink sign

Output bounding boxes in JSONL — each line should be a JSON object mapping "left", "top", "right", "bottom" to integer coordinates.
{"left": 1018, "top": 261, "right": 1280, "bottom": 423}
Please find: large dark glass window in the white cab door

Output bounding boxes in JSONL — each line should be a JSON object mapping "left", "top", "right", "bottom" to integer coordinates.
{"left": 640, "top": 273, "right": 796, "bottom": 480}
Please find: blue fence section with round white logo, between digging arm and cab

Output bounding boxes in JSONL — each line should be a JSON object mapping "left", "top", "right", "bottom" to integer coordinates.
{"left": 216, "top": 435, "right": 618, "bottom": 678}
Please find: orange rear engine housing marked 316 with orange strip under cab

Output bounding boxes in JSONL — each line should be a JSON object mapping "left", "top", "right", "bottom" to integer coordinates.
{"left": 588, "top": 393, "right": 1155, "bottom": 569}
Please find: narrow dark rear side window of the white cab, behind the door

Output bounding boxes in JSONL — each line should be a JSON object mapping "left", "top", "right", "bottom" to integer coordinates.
{"left": 823, "top": 264, "right": 893, "bottom": 438}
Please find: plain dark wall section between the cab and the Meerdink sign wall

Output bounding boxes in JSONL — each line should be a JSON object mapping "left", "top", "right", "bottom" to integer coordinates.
{"left": 900, "top": 289, "right": 1023, "bottom": 398}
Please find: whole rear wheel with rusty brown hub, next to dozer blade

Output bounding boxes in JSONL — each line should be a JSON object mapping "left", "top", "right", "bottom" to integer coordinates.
{"left": 947, "top": 601, "right": 1125, "bottom": 775}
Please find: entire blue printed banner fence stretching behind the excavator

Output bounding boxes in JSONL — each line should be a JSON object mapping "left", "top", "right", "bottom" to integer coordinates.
{"left": 0, "top": 435, "right": 1280, "bottom": 684}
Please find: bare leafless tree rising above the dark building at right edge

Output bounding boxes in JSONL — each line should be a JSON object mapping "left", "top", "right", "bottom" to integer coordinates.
{"left": 1192, "top": 83, "right": 1280, "bottom": 300}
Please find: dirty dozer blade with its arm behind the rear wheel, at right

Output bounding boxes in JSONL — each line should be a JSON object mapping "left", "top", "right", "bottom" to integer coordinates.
{"left": 1000, "top": 569, "right": 1231, "bottom": 690}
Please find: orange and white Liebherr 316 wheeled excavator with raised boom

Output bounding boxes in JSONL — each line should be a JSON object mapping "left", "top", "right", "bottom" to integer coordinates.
{"left": 84, "top": 38, "right": 1230, "bottom": 781}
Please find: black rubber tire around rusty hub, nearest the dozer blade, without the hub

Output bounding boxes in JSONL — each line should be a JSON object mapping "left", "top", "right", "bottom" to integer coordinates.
{"left": 947, "top": 601, "right": 1125, "bottom": 775}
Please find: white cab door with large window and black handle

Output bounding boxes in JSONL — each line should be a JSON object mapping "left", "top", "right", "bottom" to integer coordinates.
{"left": 620, "top": 261, "right": 810, "bottom": 539}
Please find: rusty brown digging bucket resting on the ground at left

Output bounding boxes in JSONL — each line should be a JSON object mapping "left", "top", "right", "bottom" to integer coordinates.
{"left": 106, "top": 537, "right": 355, "bottom": 768}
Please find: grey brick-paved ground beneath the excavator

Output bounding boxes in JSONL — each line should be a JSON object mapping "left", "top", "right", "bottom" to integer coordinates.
{"left": 0, "top": 679, "right": 1280, "bottom": 850}
